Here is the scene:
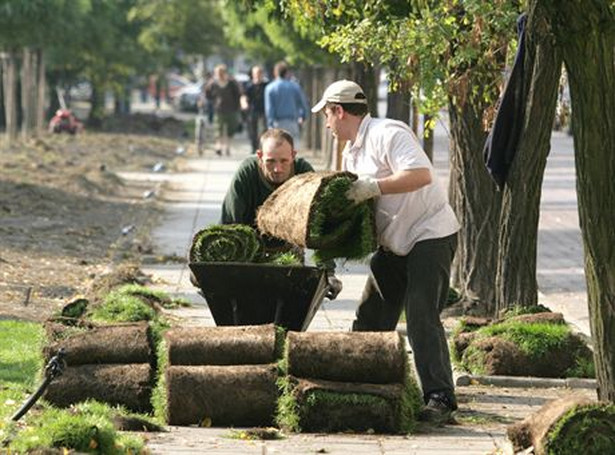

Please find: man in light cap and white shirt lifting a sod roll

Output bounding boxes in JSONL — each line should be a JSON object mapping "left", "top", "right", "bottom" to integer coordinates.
{"left": 312, "top": 80, "right": 459, "bottom": 423}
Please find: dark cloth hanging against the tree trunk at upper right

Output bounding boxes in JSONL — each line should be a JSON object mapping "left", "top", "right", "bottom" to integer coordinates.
{"left": 483, "top": 13, "right": 527, "bottom": 189}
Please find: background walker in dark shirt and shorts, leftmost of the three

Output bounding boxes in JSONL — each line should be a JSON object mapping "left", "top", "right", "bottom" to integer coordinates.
{"left": 205, "top": 64, "right": 241, "bottom": 156}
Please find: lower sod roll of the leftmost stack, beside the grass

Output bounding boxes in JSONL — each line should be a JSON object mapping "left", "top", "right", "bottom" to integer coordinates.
{"left": 44, "top": 363, "right": 152, "bottom": 412}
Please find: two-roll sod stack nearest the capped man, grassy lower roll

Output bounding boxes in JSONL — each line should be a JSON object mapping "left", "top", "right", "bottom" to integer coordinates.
{"left": 277, "top": 332, "right": 421, "bottom": 433}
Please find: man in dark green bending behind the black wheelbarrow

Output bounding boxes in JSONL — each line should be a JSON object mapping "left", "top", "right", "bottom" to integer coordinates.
{"left": 220, "top": 128, "right": 342, "bottom": 300}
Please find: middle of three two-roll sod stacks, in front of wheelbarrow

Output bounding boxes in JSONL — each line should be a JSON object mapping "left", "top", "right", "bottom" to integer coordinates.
{"left": 161, "top": 324, "right": 283, "bottom": 426}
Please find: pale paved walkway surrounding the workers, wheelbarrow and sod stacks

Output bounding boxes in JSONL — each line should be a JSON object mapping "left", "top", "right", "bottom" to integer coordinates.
{"left": 118, "top": 127, "right": 591, "bottom": 454}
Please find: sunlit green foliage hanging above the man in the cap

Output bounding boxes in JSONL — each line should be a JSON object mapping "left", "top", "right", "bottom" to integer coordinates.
{"left": 282, "top": 0, "right": 519, "bottom": 114}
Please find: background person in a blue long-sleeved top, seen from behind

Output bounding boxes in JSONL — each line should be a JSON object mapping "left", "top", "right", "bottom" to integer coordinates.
{"left": 265, "top": 62, "right": 309, "bottom": 144}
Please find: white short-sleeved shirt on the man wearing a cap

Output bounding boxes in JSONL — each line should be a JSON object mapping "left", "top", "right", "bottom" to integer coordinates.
{"left": 342, "top": 114, "right": 459, "bottom": 256}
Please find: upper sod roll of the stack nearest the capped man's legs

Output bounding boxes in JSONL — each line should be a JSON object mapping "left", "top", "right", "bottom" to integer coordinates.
{"left": 285, "top": 332, "right": 407, "bottom": 384}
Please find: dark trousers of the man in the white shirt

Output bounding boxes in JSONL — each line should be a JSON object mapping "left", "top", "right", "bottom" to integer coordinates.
{"left": 352, "top": 234, "right": 457, "bottom": 402}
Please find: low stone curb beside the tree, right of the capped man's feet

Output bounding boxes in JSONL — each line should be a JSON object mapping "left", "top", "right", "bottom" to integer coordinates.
{"left": 455, "top": 374, "right": 597, "bottom": 389}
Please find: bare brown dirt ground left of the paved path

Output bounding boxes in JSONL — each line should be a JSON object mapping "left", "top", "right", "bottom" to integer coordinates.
{"left": 0, "top": 115, "right": 185, "bottom": 321}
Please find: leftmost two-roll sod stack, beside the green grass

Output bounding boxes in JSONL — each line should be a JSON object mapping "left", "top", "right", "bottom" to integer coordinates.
{"left": 43, "top": 322, "right": 154, "bottom": 412}
